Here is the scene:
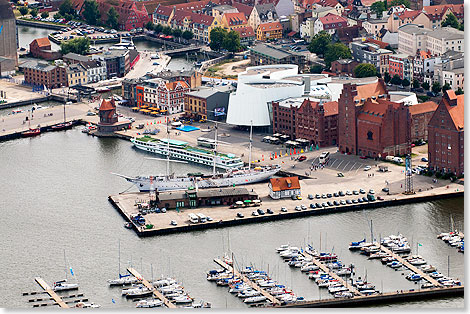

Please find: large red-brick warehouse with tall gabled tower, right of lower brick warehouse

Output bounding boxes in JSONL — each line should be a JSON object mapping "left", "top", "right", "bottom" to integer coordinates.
{"left": 338, "top": 80, "right": 411, "bottom": 158}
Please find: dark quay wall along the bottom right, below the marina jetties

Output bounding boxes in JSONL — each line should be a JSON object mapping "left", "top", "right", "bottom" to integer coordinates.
{"left": 274, "top": 286, "right": 464, "bottom": 308}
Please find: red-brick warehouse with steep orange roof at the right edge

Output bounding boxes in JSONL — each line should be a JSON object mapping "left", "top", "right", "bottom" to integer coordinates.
{"left": 428, "top": 90, "right": 465, "bottom": 176}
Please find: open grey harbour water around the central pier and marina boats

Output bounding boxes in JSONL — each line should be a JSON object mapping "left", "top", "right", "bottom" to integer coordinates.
{"left": 0, "top": 127, "right": 464, "bottom": 308}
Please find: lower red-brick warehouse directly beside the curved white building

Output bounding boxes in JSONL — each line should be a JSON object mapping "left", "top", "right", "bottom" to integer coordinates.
{"left": 272, "top": 98, "right": 338, "bottom": 147}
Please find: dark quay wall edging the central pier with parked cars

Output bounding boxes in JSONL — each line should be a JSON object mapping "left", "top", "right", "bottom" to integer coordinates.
{"left": 108, "top": 191, "right": 464, "bottom": 237}
